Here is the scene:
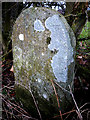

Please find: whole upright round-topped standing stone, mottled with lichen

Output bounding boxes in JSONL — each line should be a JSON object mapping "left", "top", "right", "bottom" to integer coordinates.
{"left": 12, "top": 8, "right": 75, "bottom": 119}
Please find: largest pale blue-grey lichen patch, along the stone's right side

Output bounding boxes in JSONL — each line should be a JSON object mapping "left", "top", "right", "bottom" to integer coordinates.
{"left": 45, "top": 15, "right": 73, "bottom": 82}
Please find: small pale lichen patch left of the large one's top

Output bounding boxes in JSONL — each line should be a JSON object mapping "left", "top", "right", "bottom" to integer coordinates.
{"left": 34, "top": 19, "right": 45, "bottom": 32}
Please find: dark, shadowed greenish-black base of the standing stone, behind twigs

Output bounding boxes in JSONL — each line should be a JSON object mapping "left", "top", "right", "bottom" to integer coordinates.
{"left": 15, "top": 85, "right": 73, "bottom": 120}
